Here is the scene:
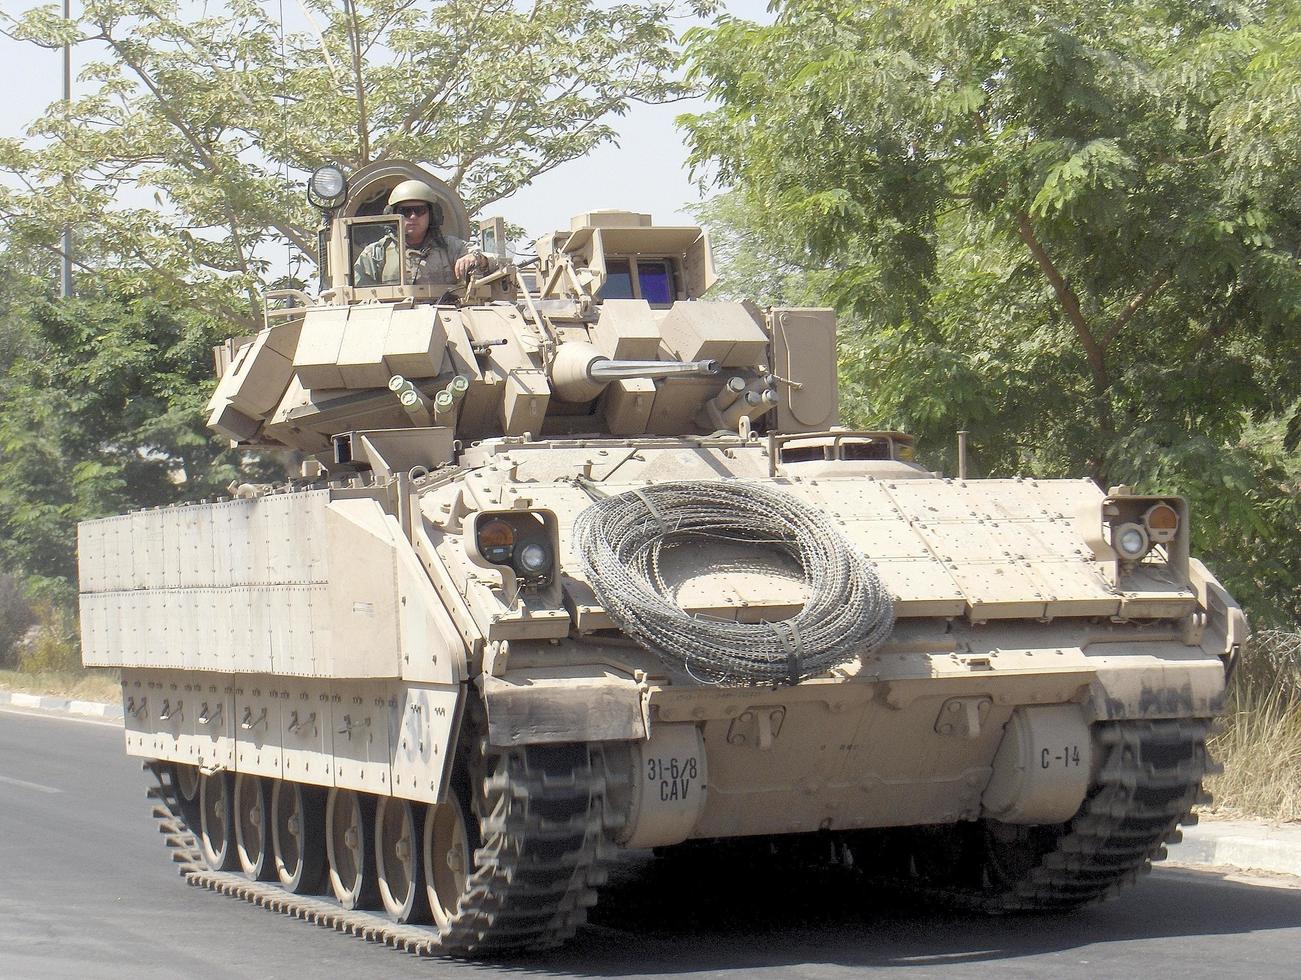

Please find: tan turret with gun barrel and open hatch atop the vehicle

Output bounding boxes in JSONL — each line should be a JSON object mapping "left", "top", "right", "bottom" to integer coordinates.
{"left": 202, "top": 161, "right": 837, "bottom": 469}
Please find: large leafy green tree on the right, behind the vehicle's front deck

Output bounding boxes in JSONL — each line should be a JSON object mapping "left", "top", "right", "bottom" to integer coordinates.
{"left": 684, "top": 0, "right": 1301, "bottom": 617}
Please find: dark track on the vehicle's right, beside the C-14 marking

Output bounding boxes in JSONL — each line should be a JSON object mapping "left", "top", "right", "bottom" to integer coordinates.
{"left": 877, "top": 720, "right": 1219, "bottom": 914}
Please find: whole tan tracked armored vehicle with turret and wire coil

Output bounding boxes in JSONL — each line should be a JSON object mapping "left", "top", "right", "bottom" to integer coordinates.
{"left": 79, "top": 161, "right": 1245, "bottom": 955}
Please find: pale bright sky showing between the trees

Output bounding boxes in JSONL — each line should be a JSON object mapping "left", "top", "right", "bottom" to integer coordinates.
{"left": 0, "top": 0, "right": 770, "bottom": 238}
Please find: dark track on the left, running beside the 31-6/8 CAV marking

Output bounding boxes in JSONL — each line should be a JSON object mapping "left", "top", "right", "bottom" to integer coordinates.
{"left": 144, "top": 744, "right": 618, "bottom": 957}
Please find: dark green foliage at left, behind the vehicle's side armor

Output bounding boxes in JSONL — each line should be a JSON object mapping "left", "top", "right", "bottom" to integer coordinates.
{"left": 0, "top": 272, "right": 239, "bottom": 585}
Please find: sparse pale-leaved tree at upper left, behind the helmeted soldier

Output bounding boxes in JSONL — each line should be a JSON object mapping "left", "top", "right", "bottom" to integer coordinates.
{"left": 0, "top": 0, "right": 709, "bottom": 328}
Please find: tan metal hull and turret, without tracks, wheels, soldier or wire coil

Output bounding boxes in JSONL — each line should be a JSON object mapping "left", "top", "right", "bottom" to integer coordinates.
{"left": 78, "top": 154, "right": 1245, "bottom": 916}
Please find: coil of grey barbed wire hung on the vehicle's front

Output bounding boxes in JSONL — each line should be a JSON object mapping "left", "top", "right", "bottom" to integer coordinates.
{"left": 572, "top": 480, "right": 895, "bottom": 686}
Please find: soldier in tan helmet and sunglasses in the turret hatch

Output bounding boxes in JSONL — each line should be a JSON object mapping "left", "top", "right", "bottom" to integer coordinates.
{"left": 353, "top": 180, "right": 493, "bottom": 286}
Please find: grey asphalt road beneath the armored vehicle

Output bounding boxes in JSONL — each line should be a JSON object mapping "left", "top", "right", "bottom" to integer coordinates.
{"left": 0, "top": 709, "right": 1301, "bottom": 980}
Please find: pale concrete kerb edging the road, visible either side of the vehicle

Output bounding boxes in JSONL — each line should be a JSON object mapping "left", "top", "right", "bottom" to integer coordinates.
{"left": 0, "top": 691, "right": 1301, "bottom": 886}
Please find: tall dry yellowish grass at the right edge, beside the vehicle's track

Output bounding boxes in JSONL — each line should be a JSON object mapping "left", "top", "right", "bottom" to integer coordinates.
{"left": 1207, "top": 630, "right": 1301, "bottom": 821}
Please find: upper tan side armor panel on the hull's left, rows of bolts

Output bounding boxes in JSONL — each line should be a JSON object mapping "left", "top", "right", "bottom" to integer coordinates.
{"left": 79, "top": 491, "right": 464, "bottom": 683}
